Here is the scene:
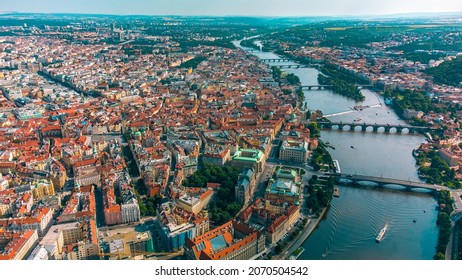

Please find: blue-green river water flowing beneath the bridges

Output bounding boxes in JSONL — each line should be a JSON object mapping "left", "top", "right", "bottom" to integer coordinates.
{"left": 236, "top": 40, "right": 438, "bottom": 260}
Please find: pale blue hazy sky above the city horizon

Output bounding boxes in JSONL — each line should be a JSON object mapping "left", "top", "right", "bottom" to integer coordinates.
{"left": 0, "top": 0, "right": 462, "bottom": 16}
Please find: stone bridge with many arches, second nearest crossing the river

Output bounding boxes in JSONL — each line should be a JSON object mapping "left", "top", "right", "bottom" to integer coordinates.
{"left": 317, "top": 122, "right": 431, "bottom": 133}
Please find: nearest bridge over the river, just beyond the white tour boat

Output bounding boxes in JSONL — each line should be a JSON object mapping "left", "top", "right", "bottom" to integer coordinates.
{"left": 332, "top": 173, "right": 450, "bottom": 191}
